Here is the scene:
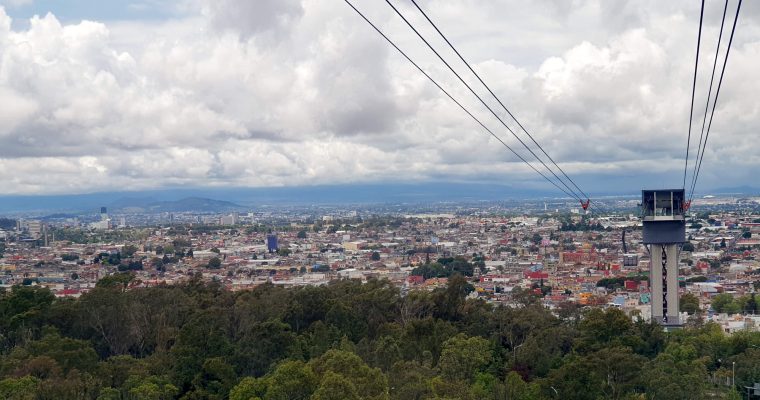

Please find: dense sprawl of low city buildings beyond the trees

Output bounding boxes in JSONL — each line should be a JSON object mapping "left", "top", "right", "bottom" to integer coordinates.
{"left": 0, "top": 199, "right": 760, "bottom": 333}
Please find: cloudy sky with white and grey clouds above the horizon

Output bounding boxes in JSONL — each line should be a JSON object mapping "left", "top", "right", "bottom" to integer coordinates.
{"left": 0, "top": 0, "right": 760, "bottom": 194}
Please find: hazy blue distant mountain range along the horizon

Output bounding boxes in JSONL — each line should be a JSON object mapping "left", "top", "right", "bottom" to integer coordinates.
{"left": 0, "top": 182, "right": 760, "bottom": 215}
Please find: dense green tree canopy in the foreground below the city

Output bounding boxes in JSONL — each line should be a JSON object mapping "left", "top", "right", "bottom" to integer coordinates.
{"left": 0, "top": 274, "right": 760, "bottom": 400}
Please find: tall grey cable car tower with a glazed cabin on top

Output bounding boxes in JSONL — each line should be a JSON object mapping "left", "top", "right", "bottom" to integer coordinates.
{"left": 641, "top": 189, "right": 689, "bottom": 327}
